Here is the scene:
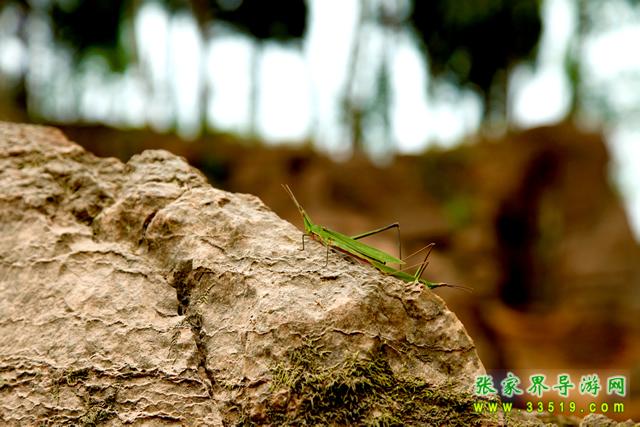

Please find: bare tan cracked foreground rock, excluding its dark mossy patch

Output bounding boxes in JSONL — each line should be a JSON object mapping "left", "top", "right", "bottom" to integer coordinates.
{"left": 0, "top": 123, "right": 484, "bottom": 425}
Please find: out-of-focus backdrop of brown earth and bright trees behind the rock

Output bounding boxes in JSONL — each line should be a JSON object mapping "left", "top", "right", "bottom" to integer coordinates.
{"left": 0, "top": 0, "right": 640, "bottom": 421}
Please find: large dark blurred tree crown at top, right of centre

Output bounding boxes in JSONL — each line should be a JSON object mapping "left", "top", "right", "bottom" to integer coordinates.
{"left": 410, "top": 0, "right": 542, "bottom": 125}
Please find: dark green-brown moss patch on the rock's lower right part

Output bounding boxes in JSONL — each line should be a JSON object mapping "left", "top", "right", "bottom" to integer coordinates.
{"left": 239, "top": 342, "right": 490, "bottom": 426}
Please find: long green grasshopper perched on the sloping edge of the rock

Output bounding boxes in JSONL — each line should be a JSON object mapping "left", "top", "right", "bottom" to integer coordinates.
{"left": 282, "top": 184, "right": 454, "bottom": 289}
